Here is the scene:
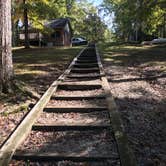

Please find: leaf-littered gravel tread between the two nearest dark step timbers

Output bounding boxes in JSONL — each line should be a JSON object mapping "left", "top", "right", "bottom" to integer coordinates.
{"left": 18, "top": 130, "right": 118, "bottom": 158}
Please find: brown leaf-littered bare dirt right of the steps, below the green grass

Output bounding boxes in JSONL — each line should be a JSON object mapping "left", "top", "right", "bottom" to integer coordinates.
{"left": 104, "top": 62, "right": 166, "bottom": 166}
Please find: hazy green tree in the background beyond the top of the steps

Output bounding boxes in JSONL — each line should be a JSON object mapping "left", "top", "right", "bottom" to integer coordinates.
{"left": 69, "top": 0, "right": 107, "bottom": 41}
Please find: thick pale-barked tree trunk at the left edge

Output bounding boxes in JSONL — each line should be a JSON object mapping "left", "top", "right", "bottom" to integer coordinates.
{"left": 0, "top": 0, "right": 14, "bottom": 93}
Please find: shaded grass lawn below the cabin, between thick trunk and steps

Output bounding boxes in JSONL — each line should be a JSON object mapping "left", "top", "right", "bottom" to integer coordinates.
{"left": 13, "top": 47, "right": 83, "bottom": 82}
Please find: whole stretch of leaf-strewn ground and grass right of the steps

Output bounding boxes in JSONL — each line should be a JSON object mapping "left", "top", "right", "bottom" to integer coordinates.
{"left": 100, "top": 44, "right": 166, "bottom": 166}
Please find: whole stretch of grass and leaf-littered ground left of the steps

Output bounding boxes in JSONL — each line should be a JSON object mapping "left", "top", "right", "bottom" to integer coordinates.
{"left": 0, "top": 47, "right": 82, "bottom": 145}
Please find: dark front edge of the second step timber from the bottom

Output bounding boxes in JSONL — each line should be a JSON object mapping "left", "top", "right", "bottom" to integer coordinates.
{"left": 32, "top": 124, "right": 110, "bottom": 132}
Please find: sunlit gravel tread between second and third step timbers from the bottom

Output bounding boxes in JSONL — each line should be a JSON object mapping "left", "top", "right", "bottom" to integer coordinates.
{"left": 37, "top": 112, "right": 110, "bottom": 125}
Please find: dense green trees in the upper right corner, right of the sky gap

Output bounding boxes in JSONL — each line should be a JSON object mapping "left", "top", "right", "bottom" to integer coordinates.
{"left": 104, "top": 0, "right": 166, "bottom": 41}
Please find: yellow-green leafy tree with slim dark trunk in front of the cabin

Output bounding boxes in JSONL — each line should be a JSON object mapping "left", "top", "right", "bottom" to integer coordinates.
{"left": 12, "top": 0, "right": 67, "bottom": 48}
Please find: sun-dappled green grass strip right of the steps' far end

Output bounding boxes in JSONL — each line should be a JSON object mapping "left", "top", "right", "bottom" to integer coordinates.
{"left": 99, "top": 43, "right": 166, "bottom": 72}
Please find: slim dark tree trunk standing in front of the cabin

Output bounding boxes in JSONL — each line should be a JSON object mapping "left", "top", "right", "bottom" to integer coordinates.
{"left": 23, "top": 0, "right": 30, "bottom": 48}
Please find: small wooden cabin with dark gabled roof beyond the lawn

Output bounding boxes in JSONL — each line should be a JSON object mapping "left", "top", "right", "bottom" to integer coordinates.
{"left": 19, "top": 18, "right": 72, "bottom": 47}
